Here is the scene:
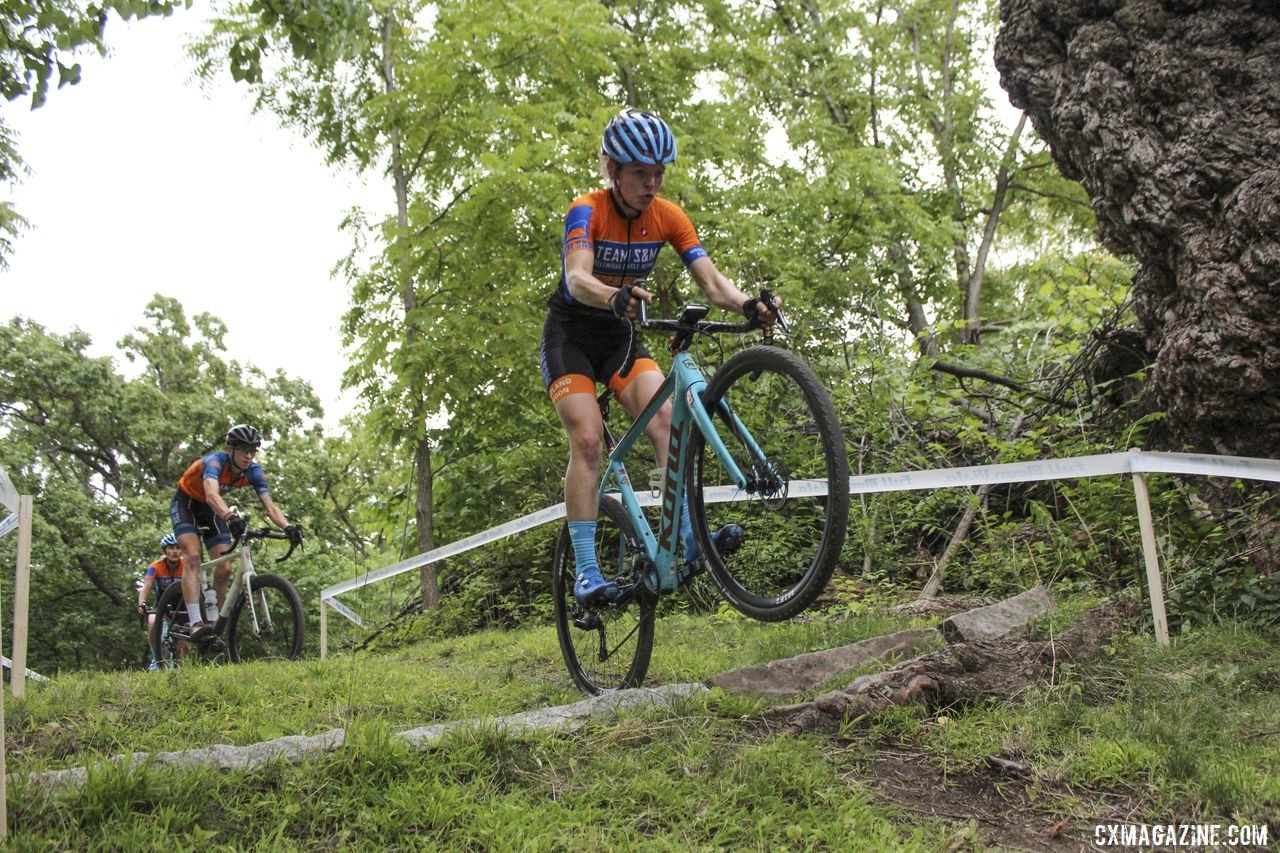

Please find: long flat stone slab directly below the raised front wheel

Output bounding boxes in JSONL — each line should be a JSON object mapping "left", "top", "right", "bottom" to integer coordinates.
{"left": 708, "top": 628, "right": 937, "bottom": 699}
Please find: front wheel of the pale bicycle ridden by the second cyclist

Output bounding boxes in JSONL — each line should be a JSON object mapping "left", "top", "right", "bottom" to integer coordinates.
{"left": 227, "top": 574, "right": 303, "bottom": 663}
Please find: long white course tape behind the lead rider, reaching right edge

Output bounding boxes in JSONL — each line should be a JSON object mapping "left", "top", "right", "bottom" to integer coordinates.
{"left": 320, "top": 451, "right": 1280, "bottom": 619}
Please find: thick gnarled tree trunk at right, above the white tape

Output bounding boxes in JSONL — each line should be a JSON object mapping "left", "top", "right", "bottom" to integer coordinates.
{"left": 996, "top": 0, "right": 1280, "bottom": 456}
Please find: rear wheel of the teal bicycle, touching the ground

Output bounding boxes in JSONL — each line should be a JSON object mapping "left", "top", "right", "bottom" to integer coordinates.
{"left": 552, "top": 496, "right": 654, "bottom": 695}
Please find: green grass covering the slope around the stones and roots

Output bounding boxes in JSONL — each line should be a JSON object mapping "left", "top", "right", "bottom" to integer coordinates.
{"left": 5, "top": 594, "right": 1280, "bottom": 850}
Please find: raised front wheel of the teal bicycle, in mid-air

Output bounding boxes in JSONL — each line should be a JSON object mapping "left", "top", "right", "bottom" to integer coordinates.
{"left": 686, "top": 346, "right": 849, "bottom": 621}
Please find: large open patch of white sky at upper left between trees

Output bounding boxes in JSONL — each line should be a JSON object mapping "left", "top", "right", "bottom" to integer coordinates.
{"left": 0, "top": 10, "right": 390, "bottom": 425}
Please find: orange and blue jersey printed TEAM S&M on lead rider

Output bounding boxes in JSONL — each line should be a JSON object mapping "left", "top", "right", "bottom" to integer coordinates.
{"left": 548, "top": 190, "right": 707, "bottom": 316}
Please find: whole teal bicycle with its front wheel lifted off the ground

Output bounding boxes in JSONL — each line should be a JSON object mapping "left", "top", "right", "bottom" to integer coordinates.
{"left": 552, "top": 291, "right": 849, "bottom": 694}
